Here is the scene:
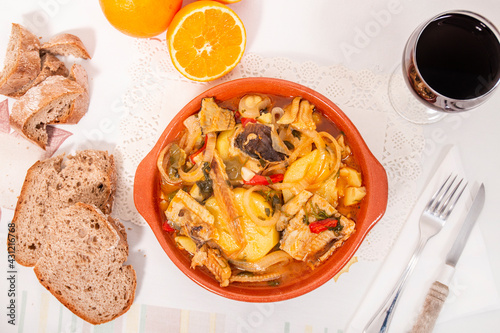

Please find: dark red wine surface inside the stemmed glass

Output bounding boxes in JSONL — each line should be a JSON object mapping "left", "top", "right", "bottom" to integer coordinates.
{"left": 416, "top": 13, "right": 500, "bottom": 99}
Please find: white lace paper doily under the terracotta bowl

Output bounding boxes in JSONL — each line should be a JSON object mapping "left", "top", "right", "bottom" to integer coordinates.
{"left": 114, "top": 39, "right": 424, "bottom": 261}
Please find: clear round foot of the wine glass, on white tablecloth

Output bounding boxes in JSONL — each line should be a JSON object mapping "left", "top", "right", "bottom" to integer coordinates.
{"left": 389, "top": 65, "right": 446, "bottom": 124}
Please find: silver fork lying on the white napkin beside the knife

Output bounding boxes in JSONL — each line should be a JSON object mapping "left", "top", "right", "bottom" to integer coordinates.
{"left": 363, "top": 175, "right": 467, "bottom": 333}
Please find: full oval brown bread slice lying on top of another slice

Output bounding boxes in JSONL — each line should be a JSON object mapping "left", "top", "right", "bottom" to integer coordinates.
{"left": 34, "top": 203, "right": 137, "bottom": 325}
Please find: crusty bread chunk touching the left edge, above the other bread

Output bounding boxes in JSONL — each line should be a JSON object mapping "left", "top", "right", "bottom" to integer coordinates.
{"left": 0, "top": 23, "right": 41, "bottom": 95}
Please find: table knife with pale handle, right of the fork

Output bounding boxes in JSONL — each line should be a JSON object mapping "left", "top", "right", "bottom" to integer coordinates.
{"left": 411, "top": 184, "right": 485, "bottom": 333}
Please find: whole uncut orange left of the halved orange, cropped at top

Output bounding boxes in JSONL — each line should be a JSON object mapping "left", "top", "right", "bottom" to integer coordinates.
{"left": 99, "top": 0, "right": 182, "bottom": 37}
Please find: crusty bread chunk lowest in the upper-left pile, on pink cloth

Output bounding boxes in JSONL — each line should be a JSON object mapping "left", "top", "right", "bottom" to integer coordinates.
{"left": 10, "top": 75, "right": 84, "bottom": 149}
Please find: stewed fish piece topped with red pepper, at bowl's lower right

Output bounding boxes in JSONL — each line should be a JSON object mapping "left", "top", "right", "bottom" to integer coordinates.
{"left": 280, "top": 194, "right": 355, "bottom": 268}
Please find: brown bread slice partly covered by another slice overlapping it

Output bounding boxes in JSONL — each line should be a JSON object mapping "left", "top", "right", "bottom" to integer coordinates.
{"left": 12, "top": 150, "right": 116, "bottom": 266}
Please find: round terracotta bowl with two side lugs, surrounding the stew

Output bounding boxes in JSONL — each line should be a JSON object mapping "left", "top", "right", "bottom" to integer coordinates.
{"left": 134, "top": 78, "right": 388, "bottom": 302}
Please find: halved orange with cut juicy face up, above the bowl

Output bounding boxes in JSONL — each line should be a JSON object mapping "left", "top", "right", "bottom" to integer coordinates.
{"left": 167, "top": 1, "right": 246, "bottom": 81}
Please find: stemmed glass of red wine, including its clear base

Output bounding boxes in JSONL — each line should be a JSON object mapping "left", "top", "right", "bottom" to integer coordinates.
{"left": 389, "top": 10, "right": 500, "bottom": 124}
